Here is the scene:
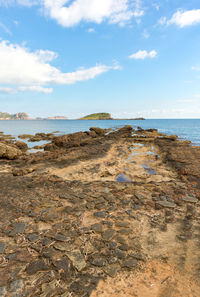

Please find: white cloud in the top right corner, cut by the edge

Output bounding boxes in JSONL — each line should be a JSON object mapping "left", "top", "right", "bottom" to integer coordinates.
{"left": 159, "top": 9, "right": 200, "bottom": 28}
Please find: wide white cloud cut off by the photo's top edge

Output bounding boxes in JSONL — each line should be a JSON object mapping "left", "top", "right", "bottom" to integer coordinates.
{"left": 43, "top": 0, "right": 144, "bottom": 27}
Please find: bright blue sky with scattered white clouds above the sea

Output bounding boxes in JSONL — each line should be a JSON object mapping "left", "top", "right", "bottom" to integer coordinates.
{"left": 0, "top": 0, "right": 200, "bottom": 118}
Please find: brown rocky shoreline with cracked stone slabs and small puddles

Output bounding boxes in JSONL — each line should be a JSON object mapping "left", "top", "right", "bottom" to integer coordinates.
{"left": 0, "top": 126, "right": 200, "bottom": 297}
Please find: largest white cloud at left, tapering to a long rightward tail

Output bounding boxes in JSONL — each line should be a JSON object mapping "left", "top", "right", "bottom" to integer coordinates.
{"left": 0, "top": 41, "right": 119, "bottom": 93}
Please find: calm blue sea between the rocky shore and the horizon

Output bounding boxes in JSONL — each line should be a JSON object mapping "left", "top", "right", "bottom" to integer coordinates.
{"left": 0, "top": 119, "right": 200, "bottom": 145}
